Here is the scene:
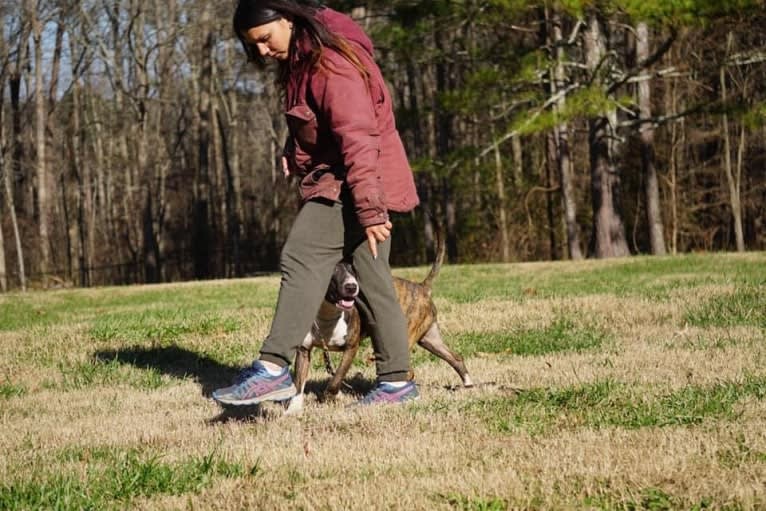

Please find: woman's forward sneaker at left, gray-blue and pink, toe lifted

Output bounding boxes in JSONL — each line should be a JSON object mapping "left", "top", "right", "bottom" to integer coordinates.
{"left": 213, "top": 360, "right": 296, "bottom": 405}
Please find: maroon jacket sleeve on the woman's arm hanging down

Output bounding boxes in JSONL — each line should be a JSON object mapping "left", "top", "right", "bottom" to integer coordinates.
{"left": 311, "top": 50, "right": 388, "bottom": 227}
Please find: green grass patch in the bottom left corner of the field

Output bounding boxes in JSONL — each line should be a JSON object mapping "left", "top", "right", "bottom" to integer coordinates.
{"left": 0, "top": 449, "right": 247, "bottom": 510}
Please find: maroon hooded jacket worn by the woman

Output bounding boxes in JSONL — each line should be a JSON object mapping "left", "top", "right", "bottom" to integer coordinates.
{"left": 285, "top": 8, "right": 419, "bottom": 227}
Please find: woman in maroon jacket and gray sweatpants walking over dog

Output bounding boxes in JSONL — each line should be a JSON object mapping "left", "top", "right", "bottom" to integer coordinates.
{"left": 213, "top": 0, "right": 418, "bottom": 405}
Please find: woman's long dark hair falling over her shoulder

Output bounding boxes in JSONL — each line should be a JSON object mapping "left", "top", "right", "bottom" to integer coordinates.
{"left": 233, "top": 0, "right": 369, "bottom": 87}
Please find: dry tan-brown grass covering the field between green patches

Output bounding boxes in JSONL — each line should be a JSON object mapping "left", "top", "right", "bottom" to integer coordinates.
{"left": 0, "top": 255, "right": 766, "bottom": 509}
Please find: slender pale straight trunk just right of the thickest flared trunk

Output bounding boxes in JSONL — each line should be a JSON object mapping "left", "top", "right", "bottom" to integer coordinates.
{"left": 636, "top": 22, "right": 667, "bottom": 255}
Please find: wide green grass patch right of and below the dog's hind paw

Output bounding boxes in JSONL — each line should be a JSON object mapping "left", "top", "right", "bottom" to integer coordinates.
{"left": 428, "top": 376, "right": 766, "bottom": 434}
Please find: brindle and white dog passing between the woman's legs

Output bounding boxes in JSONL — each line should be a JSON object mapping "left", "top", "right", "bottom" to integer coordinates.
{"left": 287, "top": 237, "right": 473, "bottom": 414}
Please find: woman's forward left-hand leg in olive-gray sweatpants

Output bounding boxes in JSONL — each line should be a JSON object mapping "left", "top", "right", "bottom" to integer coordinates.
{"left": 260, "top": 201, "right": 344, "bottom": 367}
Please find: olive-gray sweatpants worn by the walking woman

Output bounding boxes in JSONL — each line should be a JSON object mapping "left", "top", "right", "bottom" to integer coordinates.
{"left": 260, "top": 199, "right": 410, "bottom": 381}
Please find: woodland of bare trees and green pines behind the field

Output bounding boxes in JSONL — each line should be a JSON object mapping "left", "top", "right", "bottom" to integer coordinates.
{"left": 0, "top": 0, "right": 766, "bottom": 290}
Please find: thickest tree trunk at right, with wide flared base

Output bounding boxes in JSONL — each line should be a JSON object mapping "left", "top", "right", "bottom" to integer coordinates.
{"left": 585, "top": 14, "right": 630, "bottom": 258}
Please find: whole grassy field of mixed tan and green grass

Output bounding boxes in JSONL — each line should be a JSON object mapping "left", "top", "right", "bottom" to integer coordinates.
{"left": 0, "top": 253, "right": 766, "bottom": 510}
